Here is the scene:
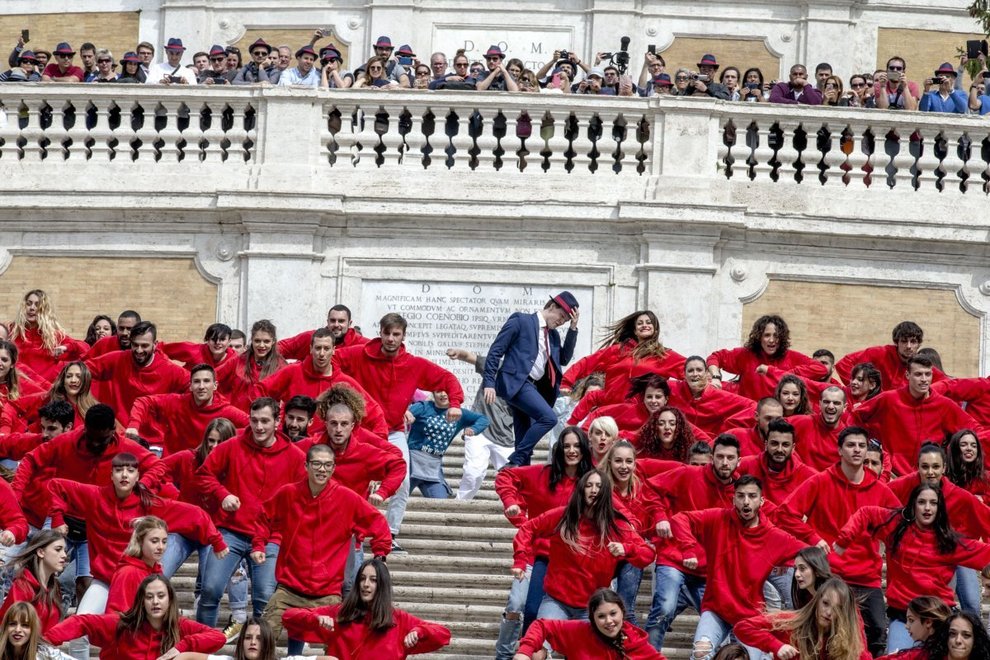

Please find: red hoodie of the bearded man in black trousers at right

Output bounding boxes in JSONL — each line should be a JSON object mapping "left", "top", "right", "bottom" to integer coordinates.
{"left": 777, "top": 465, "right": 900, "bottom": 588}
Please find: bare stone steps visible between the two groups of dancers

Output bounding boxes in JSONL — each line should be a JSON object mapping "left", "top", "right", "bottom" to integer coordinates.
{"left": 174, "top": 439, "right": 697, "bottom": 660}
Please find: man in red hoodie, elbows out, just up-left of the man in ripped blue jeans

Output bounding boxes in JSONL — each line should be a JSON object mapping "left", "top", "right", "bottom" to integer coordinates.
{"left": 126, "top": 364, "right": 248, "bottom": 457}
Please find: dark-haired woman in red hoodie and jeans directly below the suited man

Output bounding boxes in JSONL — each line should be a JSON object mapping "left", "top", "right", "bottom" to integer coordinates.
{"left": 495, "top": 426, "right": 593, "bottom": 660}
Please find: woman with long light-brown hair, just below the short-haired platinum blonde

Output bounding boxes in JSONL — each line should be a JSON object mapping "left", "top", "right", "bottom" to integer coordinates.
{"left": 602, "top": 440, "right": 662, "bottom": 625}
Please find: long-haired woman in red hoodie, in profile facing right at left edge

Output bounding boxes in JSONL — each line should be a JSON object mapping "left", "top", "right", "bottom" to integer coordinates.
{"left": 0, "top": 529, "right": 69, "bottom": 632}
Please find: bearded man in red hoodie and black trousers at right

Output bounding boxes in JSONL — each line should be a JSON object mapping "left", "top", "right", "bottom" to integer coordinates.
{"left": 777, "top": 426, "right": 900, "bottom": 657}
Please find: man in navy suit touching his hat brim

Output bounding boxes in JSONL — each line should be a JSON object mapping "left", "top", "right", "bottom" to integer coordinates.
{"left": 482, "top": 291, "right": 578, "bottom": 466}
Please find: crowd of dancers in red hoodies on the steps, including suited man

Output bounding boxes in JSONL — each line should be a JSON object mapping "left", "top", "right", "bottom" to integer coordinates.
{"left": 0, "top": 284, "right": 990, "bottom": 660}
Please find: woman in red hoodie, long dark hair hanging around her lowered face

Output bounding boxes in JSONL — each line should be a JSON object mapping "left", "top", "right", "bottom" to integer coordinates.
{"left": 512, "top": 470, "right": 656, "bottom": 619}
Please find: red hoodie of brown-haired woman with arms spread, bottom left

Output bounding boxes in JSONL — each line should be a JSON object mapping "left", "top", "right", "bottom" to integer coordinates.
{"left": 45, "top": 614, "right": 227, "bottom": 660}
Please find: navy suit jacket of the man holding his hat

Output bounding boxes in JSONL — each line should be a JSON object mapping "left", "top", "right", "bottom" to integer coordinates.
{"left": 482, "top": 312, "right": 577, "bottom": 405}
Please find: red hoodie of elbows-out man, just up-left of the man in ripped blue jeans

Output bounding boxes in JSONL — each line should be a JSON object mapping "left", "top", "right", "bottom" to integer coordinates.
{"left": 129, "top": 392, "right": 251, "bottom": 457}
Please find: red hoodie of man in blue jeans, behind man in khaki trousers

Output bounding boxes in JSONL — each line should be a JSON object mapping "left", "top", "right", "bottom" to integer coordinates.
{"left": 196, "top": 428, "right": 306, "bottom": 536}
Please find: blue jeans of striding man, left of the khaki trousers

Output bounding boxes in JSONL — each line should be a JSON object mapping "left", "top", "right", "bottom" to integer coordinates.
{"left": 196, "top": 527, "right": 278, "bottom": 627}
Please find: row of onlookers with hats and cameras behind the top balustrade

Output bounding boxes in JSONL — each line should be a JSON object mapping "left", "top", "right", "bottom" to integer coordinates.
{"left": 0, "top": 30, "right": 990, "bottom": 115}
